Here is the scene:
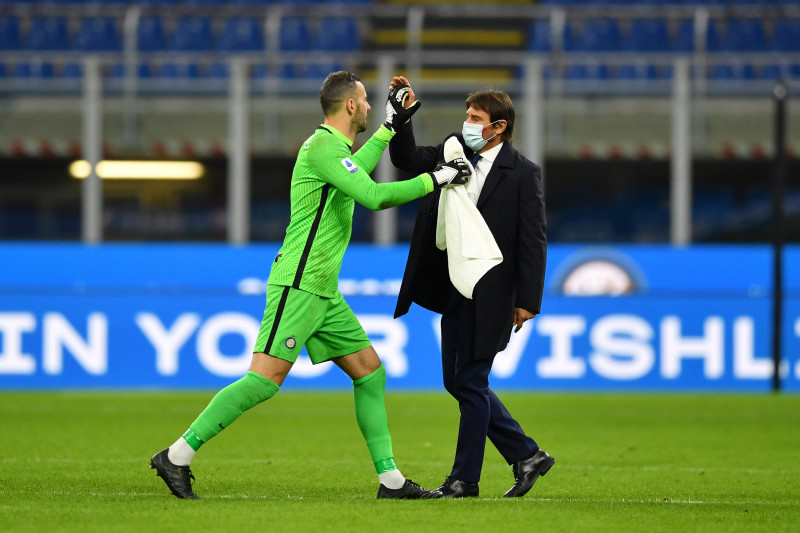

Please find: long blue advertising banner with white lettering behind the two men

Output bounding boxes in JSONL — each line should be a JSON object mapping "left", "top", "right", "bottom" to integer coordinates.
{"left": 0, "top": 244, "right": 800, "bottom": 392}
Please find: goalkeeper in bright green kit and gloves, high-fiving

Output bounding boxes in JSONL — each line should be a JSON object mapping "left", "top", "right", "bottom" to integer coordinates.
{"left": 150, "top": 72, "right": 471, "bottom": 499}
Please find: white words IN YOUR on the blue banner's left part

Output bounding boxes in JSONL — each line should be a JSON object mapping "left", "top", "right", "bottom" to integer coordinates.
{"left": 0, "top": 312, "right": 408, "bottom": 378}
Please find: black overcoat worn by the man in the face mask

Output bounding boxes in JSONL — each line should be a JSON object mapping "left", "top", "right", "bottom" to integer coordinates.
{"left": 389, "top": 122, "right": 547, "bottom": 359}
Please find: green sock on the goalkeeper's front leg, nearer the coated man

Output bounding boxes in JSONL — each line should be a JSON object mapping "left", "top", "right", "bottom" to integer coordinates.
{"left": 353, "top": 365, "right": 397, "bottom": 474}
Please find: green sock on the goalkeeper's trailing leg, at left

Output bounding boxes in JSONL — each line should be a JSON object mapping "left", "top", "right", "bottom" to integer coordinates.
{"left": 183, "top": 371, "right": 280, "bottom": 451}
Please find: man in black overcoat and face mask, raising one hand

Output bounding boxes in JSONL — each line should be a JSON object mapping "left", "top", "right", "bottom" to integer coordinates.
{"left": 389, "top": 77, "right": 555, "bottom": 498}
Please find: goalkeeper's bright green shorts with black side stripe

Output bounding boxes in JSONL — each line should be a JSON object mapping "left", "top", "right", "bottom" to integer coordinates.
{"left": 253, "top": 285, "right": 371, "bottom": 364}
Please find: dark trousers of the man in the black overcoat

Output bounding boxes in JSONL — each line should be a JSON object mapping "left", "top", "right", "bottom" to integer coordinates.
{"left": 441, "top": 298, "right": 539, "bottom": 483}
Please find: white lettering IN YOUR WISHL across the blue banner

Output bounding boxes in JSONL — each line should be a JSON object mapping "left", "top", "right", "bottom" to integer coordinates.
{"left": 0, "top": 312, "right": 800, "bottom": 381}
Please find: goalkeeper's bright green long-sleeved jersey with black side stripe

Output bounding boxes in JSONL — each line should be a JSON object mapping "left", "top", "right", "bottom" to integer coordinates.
{"left": 269, "top": 124, "right": 433, "bottom": 298}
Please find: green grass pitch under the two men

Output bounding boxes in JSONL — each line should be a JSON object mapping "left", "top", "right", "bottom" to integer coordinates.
{"left": 0, "top": 391, "right": 800, "bottom": 533}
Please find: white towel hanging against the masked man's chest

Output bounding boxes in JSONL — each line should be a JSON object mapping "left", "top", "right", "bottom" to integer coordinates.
{"left": 436, "top": 137, "right": 503, "bottom": 299}
